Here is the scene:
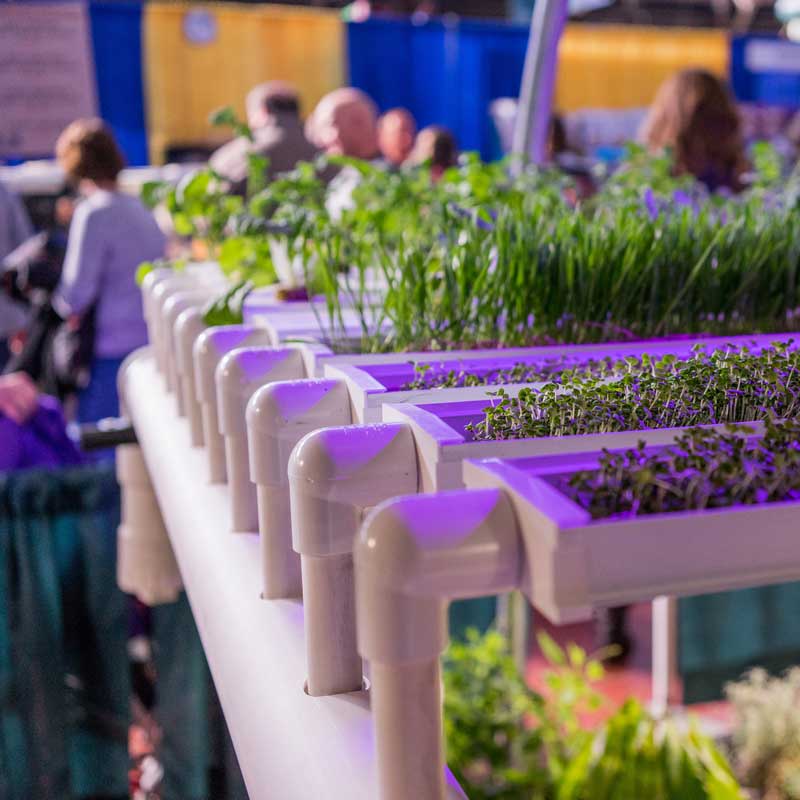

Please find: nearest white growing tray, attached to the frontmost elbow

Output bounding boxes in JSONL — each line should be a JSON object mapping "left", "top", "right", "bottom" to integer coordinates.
{"left": 464, "top": 440, "right": 800, "bottom": 622}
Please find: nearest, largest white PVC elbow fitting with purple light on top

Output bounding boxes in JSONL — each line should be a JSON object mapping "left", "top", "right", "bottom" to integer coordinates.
{"left": 353, "top": 489, "right": 524, "bottom": 664}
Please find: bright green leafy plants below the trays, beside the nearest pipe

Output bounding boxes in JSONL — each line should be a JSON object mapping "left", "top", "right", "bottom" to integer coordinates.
{"left": 444, "top": 631, "right": 744, "bottom": 800}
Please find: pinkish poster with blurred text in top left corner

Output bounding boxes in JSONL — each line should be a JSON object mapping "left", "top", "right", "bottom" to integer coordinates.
{"left": 0, "top": 2, "right": 97, "bottom": 159}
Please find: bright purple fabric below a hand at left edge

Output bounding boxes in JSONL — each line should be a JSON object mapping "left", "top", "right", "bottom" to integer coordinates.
{"left": 0, "top": 396, "right": 84, "bottom": 472}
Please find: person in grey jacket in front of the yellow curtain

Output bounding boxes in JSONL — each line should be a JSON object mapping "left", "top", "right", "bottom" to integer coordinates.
{"left": 209, "top": 81, "right": 317, "bottom": 194}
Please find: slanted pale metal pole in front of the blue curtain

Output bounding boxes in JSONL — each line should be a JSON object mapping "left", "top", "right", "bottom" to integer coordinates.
{"left": 511, "top": 0, "right": 569, "bottom": 171}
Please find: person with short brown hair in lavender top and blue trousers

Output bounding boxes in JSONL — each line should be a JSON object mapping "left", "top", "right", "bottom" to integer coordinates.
{"left": 53, "top": 119, "right": 166, "bottom": 422}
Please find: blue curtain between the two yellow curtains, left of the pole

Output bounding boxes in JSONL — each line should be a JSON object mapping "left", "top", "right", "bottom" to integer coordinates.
{"left": 347, "top": 18, "right": 528, "bottom": 159}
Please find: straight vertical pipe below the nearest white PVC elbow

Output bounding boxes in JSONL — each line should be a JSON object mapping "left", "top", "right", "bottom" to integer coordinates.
{"left": 370, "top": 657, "right": 445, "bottom": 800}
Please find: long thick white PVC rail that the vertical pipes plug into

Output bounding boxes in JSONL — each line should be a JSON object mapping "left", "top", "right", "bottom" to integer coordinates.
{"left": 122, "top": 352, "right": 465, "bottom": 800}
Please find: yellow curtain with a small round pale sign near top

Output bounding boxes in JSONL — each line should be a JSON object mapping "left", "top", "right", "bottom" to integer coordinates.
{"left": 143, "top": 2, "right": 345, "bottom": 163}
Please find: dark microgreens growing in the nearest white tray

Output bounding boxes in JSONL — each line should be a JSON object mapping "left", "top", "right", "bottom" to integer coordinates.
{"left": 555, "top": 420, "right": 800, "bottom": 519}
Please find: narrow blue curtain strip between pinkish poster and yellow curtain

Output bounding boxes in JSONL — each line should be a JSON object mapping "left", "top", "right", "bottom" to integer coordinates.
{"left": 89, "top": 0, "right": 148, "bottom": 167}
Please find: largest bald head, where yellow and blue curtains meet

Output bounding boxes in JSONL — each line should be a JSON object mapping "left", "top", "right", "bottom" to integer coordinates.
{"left": 306, "top": 87, "right": 378, "bottom": 160}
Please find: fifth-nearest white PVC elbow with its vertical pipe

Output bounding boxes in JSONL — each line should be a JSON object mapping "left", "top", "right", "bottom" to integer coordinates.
{"left": 193, "top": 325, "right": 269, "bottom": 483}
